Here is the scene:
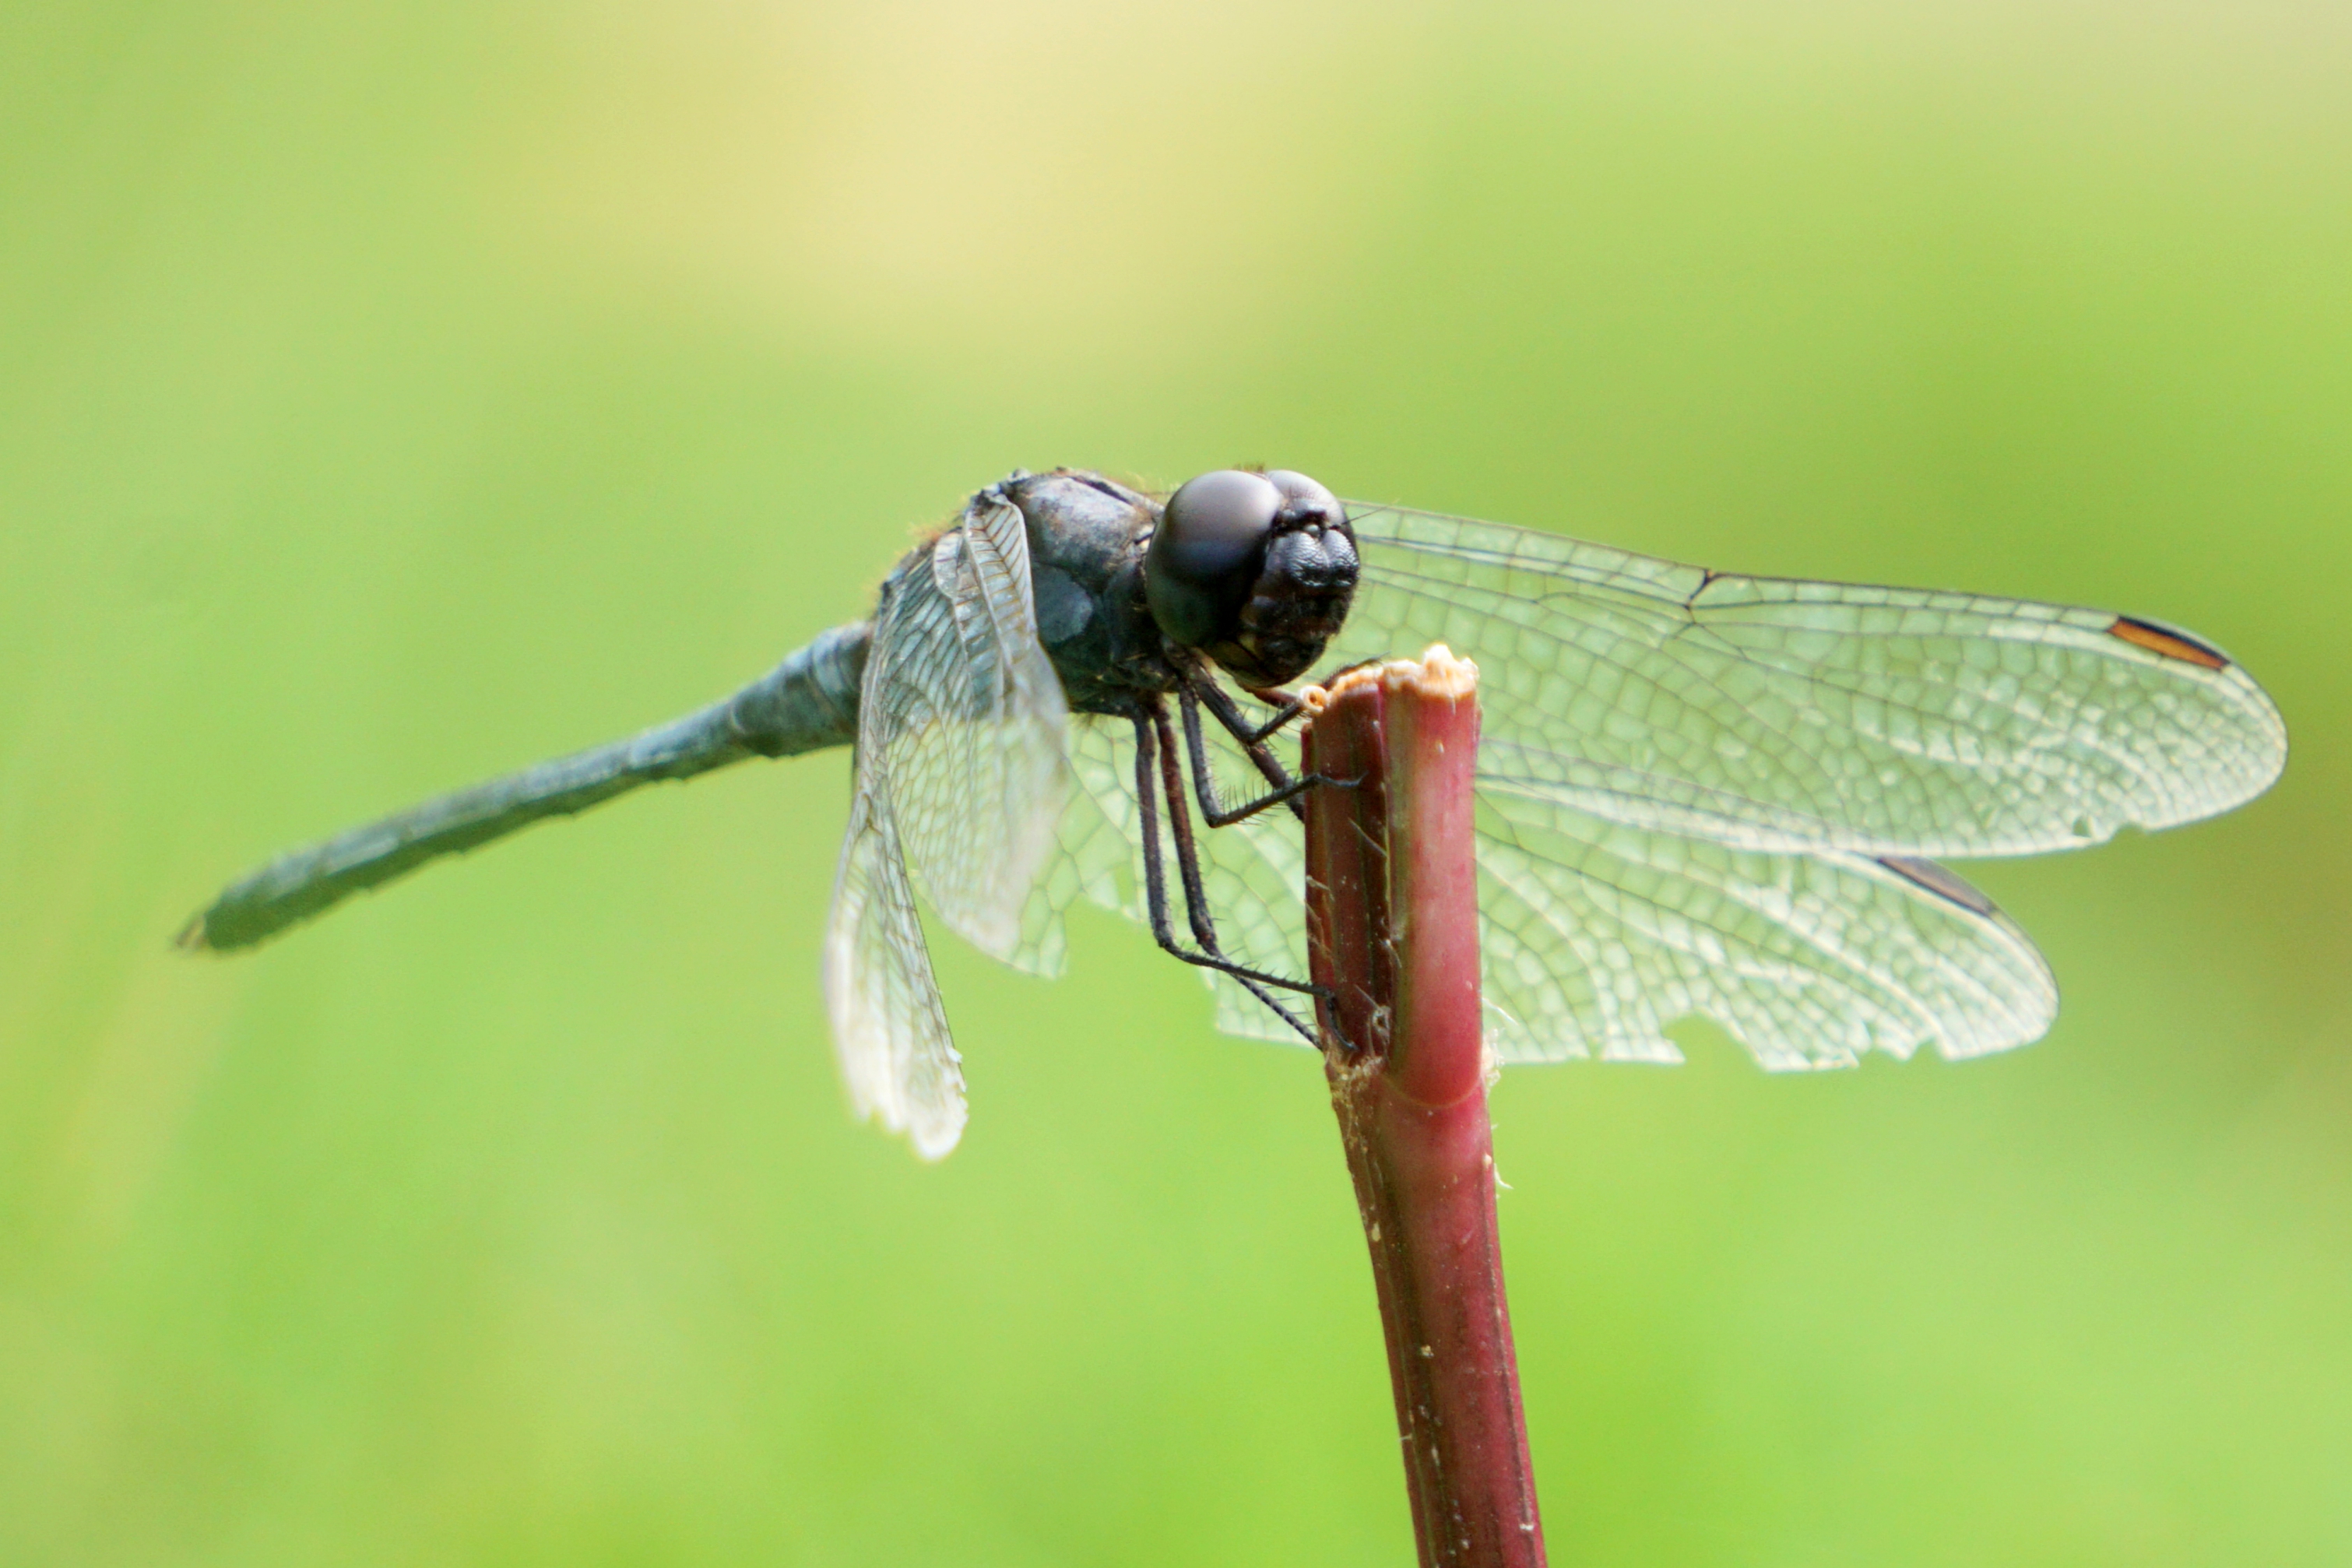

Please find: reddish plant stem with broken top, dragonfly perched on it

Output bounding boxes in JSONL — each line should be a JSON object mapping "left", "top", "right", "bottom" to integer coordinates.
{"left": 1306, "top": 649, "right": 1543, "bottom": 1568}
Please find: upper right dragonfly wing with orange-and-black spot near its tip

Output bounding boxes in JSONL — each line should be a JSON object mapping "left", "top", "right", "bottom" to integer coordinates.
{"left": 1334, "top": 503, "right": 2286, "bottom": 856}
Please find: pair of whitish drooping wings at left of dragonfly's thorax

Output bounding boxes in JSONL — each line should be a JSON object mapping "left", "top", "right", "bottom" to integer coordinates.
{"left": 825, "top": 491, "right": 1068, "bottom": 1159}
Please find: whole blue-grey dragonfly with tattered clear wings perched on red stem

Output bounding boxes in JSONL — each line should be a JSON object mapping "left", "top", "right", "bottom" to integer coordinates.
{"left": 181, "top": 468, "right": 2286, "bottom": 1159}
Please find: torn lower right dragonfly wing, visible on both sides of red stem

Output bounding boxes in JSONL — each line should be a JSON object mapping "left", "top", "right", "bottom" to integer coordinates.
{"left": 1056, "top": 717, "right": 2058, "bottom": 1070}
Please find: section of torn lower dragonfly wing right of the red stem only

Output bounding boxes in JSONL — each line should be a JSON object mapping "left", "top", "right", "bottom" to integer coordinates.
{"left": 1477, "top": 788, "right": 2058, "bottom": 1070}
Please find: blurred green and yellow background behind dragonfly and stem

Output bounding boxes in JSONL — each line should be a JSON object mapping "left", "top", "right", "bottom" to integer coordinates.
{"left": 0, "top": 0, "right": 2352, "bottom": 1568}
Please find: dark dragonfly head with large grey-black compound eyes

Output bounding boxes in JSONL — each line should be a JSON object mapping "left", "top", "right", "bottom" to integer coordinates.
{"left": 1143, "top": 468, "right": 1357, "bottom": 691}
